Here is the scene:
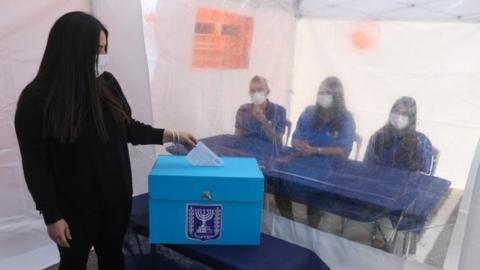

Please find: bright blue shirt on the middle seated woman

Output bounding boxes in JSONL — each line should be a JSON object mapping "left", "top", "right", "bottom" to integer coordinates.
{"left": 292, "top": 106, "right": 355, "bottom": 156}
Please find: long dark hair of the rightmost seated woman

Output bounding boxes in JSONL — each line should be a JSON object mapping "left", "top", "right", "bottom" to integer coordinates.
{"left": 374, "top": 97, "right": 423, "bottom": 171}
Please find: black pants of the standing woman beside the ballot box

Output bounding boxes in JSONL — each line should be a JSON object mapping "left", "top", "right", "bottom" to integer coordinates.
{"left": 58, "top": 202, "right": 131, "bottom": 270}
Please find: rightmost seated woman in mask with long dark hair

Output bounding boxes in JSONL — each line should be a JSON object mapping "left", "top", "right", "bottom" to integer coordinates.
{"left": 365, "top": 97, "right": 432, "bottom": 174}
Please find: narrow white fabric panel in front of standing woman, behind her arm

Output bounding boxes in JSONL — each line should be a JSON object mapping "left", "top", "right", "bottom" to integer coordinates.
{"left": 94, "top": 0, "right": 158, "bottom": 194}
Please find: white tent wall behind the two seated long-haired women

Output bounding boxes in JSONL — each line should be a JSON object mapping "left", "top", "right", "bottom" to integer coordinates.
{"left": 290, "top": 19, "right": 480, "bottom": 189}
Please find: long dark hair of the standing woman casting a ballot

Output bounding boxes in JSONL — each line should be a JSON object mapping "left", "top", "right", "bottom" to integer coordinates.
{"left": 30, "top": 11, "right": 129, "bottom": 142}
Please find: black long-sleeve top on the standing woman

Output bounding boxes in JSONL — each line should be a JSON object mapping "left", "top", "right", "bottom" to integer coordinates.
{"left": 15, "top": 72, "right": 164, "bottom": 224}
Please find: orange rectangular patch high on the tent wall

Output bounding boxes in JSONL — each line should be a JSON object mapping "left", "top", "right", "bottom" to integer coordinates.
{"left": 192, "top": 7, "right": 253, "bottom": 69}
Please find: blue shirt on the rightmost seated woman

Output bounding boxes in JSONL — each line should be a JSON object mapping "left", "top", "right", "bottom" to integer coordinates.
{"left": 364, "top": 132, "right": 433, "bottom": 174}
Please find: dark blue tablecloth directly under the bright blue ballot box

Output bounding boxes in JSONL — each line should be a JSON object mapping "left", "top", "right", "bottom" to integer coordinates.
{"left": 125, "top": 194, "right": 330, "bottom": 270}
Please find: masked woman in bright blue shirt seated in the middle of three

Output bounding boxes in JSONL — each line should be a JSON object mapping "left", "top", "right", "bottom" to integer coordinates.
{"left": 275, "top": 77, "right": 355, "bottom": 227}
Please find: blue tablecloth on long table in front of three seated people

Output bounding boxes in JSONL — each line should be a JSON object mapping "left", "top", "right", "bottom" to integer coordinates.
{"left": 167, "top": 135, "right": 451, "bottom": 232}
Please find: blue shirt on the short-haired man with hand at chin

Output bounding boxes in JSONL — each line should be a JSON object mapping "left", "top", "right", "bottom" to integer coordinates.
{"left": 235, "top": 100, "right": 287, "bottom": 141}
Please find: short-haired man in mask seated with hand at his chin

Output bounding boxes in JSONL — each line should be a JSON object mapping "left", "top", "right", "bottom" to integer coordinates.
{"left": 235, "top": 76, "right": 287, "bottom": 144}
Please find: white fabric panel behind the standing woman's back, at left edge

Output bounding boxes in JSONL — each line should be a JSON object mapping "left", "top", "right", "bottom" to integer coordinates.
{"left": 0, "top": 0, "right": 89, "bottom": 269}
